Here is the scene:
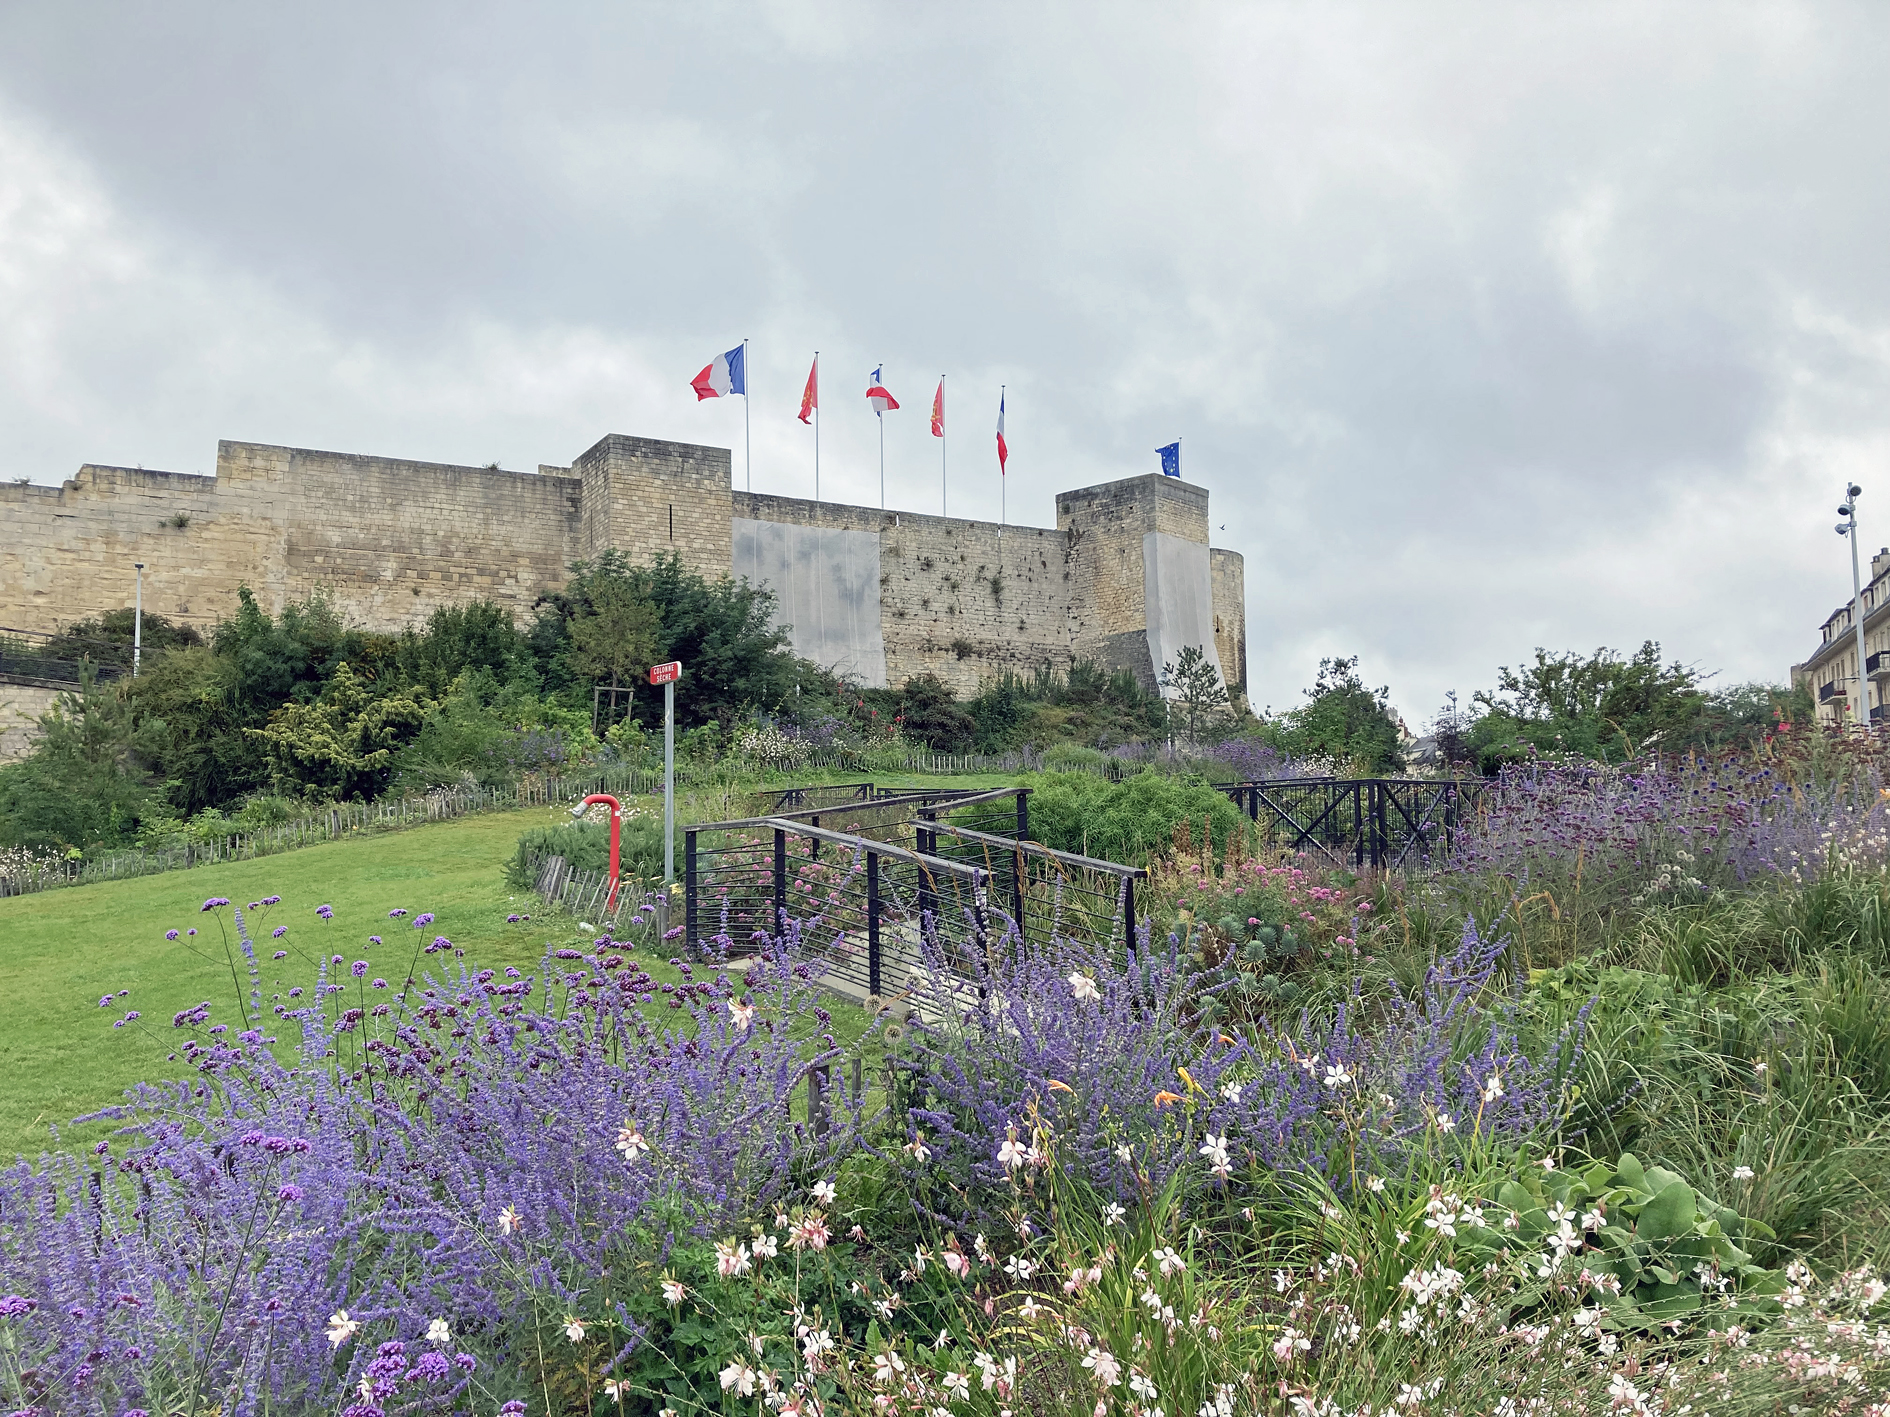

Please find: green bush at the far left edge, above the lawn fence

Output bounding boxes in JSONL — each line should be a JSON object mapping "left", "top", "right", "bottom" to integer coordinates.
{"left": 0, "top": 665, "right": 157, "bottom": 850}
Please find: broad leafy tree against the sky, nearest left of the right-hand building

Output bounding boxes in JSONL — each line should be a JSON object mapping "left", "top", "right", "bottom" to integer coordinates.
{"left": 1470, "top": 640, "right": 1709, "bottom": 773}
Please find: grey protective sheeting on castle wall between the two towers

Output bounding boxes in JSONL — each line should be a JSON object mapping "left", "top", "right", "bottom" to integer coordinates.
{"left": 731, "top": 516, "right": 888, "bottom": 690}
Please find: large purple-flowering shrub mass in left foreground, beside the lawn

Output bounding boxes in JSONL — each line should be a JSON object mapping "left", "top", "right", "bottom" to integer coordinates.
{"left": 0, "top": 901, "right": 845, "bottom": 1417}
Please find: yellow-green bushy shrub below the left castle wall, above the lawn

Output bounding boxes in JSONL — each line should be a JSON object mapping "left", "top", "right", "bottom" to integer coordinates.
{"left": 249, "top": 661, "right": 435, "bottom": 799}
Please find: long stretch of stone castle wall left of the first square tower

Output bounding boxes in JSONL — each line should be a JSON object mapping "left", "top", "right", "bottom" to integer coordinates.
{"left": 0, "top": 442, "right": 582, "bottom": 631}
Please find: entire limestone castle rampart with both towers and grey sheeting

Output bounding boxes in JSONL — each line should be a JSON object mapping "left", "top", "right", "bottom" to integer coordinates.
{"left": 0, "top": 433, "right": 1247, "bottom": 697}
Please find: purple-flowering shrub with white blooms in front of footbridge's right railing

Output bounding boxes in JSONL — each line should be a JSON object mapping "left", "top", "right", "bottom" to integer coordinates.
{"left": 907, "top": 924, "right": 1576, "bottom": 1209}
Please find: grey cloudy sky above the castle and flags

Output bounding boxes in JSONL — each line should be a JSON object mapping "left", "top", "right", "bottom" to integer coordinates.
{"left": 0, "top": 0, "right": 1890, "bottom": 727}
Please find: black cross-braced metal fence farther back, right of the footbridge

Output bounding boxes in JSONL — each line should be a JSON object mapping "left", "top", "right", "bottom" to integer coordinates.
{"left": 1225, "top": 778, "right": 1482, "bottom": 871}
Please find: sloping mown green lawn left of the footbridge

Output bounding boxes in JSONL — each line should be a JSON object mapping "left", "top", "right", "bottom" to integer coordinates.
{"left": 0, "top": 775, "right": 1004, "bottom": 1158}
